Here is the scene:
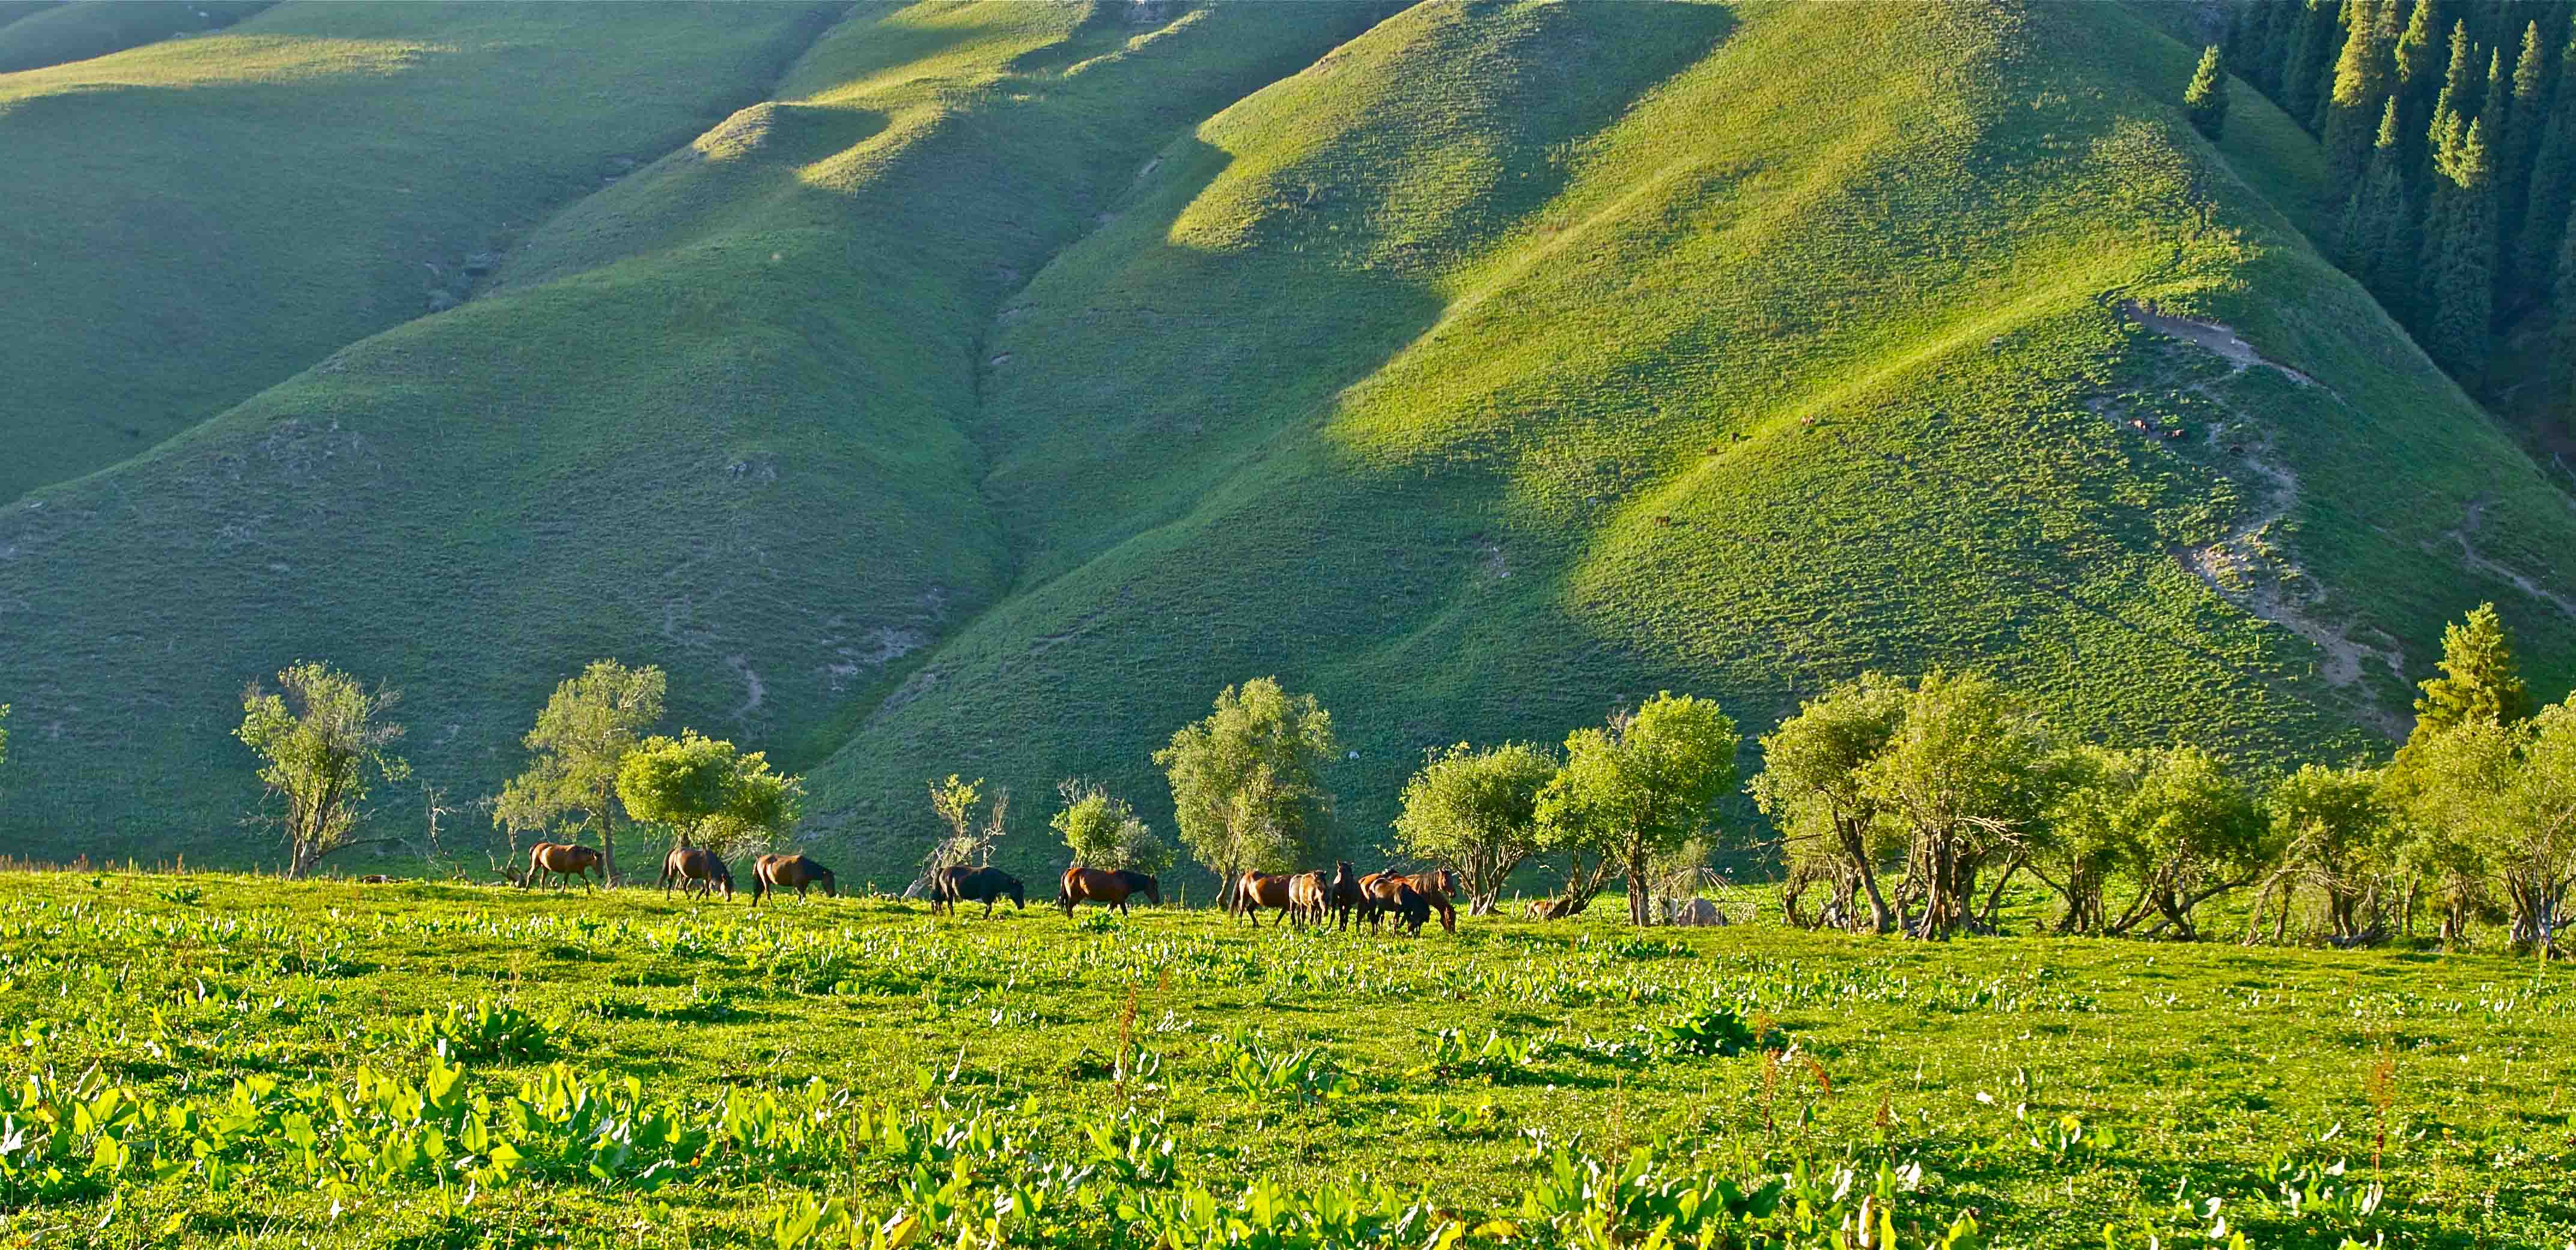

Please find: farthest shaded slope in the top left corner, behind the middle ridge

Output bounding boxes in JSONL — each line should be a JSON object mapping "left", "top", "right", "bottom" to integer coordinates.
{"left": 0, "top": 2, "right": 835, "bottom": 500}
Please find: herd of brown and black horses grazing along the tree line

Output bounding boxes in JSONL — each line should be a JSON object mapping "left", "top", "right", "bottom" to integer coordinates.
{"left": 513, "top": 843, "right": 1458, "bottom": 933}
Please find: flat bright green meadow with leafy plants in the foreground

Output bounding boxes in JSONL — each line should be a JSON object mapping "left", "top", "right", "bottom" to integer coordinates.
{"left": 0, "top": 874, "right": 2576, "bottom": 1250}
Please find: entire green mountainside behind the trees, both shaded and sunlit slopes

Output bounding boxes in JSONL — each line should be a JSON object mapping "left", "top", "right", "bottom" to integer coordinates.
{"left": 0, "top": 0, "right": 2576, "bottom": 879}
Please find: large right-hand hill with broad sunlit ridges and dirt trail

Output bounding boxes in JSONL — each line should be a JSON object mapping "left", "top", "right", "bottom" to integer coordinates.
{"left": 793, "top": 5, "right": 2576, "bottom": 866}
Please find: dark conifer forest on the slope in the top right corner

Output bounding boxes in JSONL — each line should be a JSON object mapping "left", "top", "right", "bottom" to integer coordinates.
{"left": 2220, "top": 0, "right": 2576, "bottom": 432}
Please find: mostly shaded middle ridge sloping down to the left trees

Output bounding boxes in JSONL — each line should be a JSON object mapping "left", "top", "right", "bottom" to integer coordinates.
{"left": 0, "top": 2, "right": 1373, "bottom": 856}
